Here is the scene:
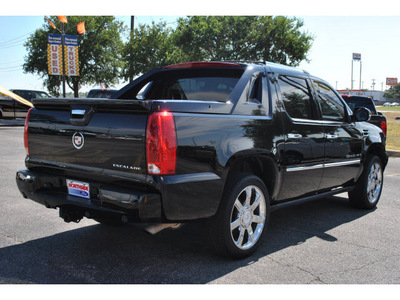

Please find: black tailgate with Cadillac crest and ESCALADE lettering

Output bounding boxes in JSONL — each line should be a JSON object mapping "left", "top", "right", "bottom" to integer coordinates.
{"left": 28, "top": 99, "right": 151, "bottom": 174}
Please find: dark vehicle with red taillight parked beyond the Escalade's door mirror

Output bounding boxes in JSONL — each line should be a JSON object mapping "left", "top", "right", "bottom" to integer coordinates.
{"left": 342, "top": 95, "right": 387, "bottom": 136}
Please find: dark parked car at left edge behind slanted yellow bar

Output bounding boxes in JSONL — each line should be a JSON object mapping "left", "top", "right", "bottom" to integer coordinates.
{"left": 0, "top": 89, "right": 51, "bottom": 118}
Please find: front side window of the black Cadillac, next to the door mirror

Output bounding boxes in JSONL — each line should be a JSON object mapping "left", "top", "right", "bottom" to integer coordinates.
{"left": 314, "top": 82, "right": 345, "bottom": 122}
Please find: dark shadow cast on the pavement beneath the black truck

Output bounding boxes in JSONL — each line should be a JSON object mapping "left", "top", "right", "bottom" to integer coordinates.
{"left": 0, "top": 197, "right": 370, "bottom": 284}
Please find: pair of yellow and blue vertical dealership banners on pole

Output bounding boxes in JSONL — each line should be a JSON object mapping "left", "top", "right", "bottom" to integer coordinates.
{"left": 47, "top": 33, "right": 79, "bottom": 76}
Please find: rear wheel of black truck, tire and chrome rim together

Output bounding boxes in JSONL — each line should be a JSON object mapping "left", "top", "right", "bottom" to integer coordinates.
{"left": 207, "top": 175, "right": 270, "bottom": 258}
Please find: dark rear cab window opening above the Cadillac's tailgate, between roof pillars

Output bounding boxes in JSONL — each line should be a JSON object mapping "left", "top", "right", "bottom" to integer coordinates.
{"left": 123, "top": 68, "right": 243, "bottom": 101}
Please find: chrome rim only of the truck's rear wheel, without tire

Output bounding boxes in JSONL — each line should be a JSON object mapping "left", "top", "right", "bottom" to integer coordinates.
{"left": 231, "top": 185, "right": 267, "bottom": 250}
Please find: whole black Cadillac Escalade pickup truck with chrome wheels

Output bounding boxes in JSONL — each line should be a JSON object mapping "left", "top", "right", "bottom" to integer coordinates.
{"left": 16, "top": 62, "right": 388, "bottom": 257}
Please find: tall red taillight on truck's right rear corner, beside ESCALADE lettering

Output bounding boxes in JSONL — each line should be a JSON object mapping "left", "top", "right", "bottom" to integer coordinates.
{"left": 146, "top": 112, "right": 176, "bottom": 175}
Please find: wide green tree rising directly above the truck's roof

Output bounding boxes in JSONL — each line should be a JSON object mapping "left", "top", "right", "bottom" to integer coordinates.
{"left": 173, "top": 16, "right": 314, "bottom": 66}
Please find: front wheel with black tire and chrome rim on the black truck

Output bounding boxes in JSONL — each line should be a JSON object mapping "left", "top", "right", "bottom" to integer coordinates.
{"left": 348, "top": 155, "right": 383, "bottom": 209}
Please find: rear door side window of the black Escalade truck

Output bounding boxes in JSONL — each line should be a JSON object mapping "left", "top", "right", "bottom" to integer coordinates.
{"left": 278, "top": 76, "right": 313, "bottom": 119}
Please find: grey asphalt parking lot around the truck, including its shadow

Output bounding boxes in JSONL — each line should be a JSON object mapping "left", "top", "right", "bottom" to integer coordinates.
{"left": 0, "top": 126, "right": 400, "bottom": 284}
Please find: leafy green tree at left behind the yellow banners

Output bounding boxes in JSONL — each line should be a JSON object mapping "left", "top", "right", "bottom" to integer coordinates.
{"left": 23, "top": 16, "right": 123, "bottom": 97}
